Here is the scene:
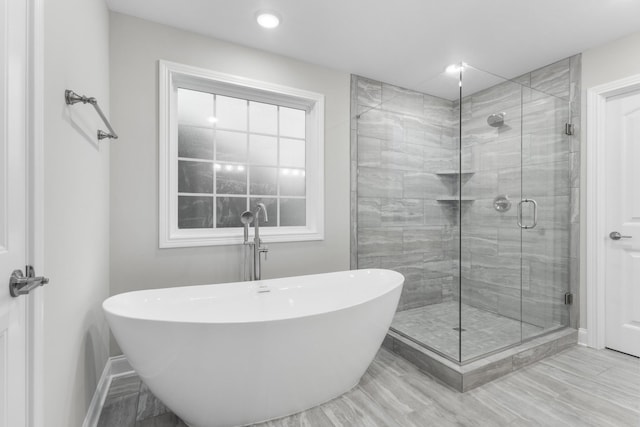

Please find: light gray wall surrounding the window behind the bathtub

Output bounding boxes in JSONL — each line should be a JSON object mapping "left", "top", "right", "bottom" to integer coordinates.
{"left": 110, "top": 13, "right": 349, "bottom": 354}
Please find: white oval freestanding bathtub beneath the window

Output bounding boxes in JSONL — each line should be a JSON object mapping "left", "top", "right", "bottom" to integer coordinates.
{"left": 102, "top": 270, "right": 404, "bottom": 427}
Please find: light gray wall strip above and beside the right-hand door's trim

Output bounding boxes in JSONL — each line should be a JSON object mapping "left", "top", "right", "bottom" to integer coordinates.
{"left": 580, "top": 32, "right": 640, "bottom": 328}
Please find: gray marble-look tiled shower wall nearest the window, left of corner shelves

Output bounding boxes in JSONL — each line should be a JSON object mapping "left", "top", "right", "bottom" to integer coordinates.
{"left": 351, "top": 76, "right": 458, "bottom": 310}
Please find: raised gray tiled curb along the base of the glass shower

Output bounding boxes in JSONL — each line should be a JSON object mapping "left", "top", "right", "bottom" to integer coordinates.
{"left": 383, "top": 328, "right": 578, "bottom": 393}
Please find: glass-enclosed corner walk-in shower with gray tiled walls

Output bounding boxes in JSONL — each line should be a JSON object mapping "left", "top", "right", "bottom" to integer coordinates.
{"left": 351, "top": 56, "right": 580, "bottom": 372}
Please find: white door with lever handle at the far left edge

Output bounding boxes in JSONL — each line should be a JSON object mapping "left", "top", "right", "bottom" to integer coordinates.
{"left": 0, "top": 0, "right": 27, "bottom": 427}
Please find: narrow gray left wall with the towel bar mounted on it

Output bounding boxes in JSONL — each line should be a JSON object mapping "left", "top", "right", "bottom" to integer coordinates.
{"left": 40, "top": 0, "right": 109, "bottom": 426}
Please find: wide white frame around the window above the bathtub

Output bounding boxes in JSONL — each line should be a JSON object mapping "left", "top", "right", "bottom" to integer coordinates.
{"left": 158, "top": 60, "right": 324, "bottom": 248}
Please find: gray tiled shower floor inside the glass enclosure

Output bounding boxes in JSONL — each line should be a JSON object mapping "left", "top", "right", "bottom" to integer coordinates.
{"left": 391, "top": 301, "right": 543, "bottom": 361}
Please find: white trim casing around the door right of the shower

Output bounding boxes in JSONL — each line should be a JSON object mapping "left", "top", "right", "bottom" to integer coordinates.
{"left": 584, "top": 74, "right": 640, "bottom": 349}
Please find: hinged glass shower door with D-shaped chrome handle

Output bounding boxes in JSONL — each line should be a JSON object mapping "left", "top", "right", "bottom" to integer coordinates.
{"left": 522, "top": 85, "right": 572, "bottom": 339}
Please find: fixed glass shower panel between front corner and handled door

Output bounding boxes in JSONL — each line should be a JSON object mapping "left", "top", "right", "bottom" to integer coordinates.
{"left": 460, "top": 67, "right": 528, "bottom": 363}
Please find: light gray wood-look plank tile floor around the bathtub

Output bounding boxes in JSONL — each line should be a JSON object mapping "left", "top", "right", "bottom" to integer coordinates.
{"left": 98, "top": 346, "right": 640, "bottom": 427}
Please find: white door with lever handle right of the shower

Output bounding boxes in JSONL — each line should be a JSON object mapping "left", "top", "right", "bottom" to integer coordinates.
{"left": 603, "top": 87, "right": 640, "bottom": 357}
